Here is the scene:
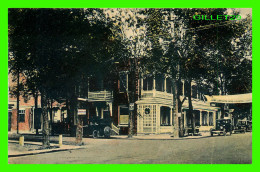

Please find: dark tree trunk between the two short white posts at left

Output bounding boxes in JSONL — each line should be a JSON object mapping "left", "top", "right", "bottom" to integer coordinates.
{"left": 41, "top": 89, "right": 50, "bottom": 148}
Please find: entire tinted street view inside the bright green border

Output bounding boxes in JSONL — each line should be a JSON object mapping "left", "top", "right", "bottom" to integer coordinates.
{"left": 8, "top": 8, "right": 253, "bottom": 164}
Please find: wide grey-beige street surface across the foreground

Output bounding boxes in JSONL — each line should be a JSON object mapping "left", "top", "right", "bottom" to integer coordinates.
{"left": 9, "top": 132, "right": 252, "bottom": 164}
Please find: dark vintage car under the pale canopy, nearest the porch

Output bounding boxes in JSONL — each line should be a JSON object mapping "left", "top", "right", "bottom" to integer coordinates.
{"left": 210, "top": 119, "right": 233, "bottom": 136}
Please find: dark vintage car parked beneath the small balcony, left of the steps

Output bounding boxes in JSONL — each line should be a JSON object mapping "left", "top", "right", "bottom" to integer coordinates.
{"left": 85, "top": 117, "right": 111, "bottom": 138}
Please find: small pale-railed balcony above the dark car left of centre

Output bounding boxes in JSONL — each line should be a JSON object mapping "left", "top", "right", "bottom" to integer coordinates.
{"left": 88, "top": 90, "right": 113, "bottom": 102}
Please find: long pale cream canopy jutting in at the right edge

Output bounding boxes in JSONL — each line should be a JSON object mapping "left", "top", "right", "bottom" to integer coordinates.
{"left": 205, "top": 93, "right": 252, "bottom": 103}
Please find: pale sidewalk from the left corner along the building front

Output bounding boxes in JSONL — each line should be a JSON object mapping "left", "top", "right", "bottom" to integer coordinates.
{"left": 8, "top": 132, "right": 210, "bottom": 158}
